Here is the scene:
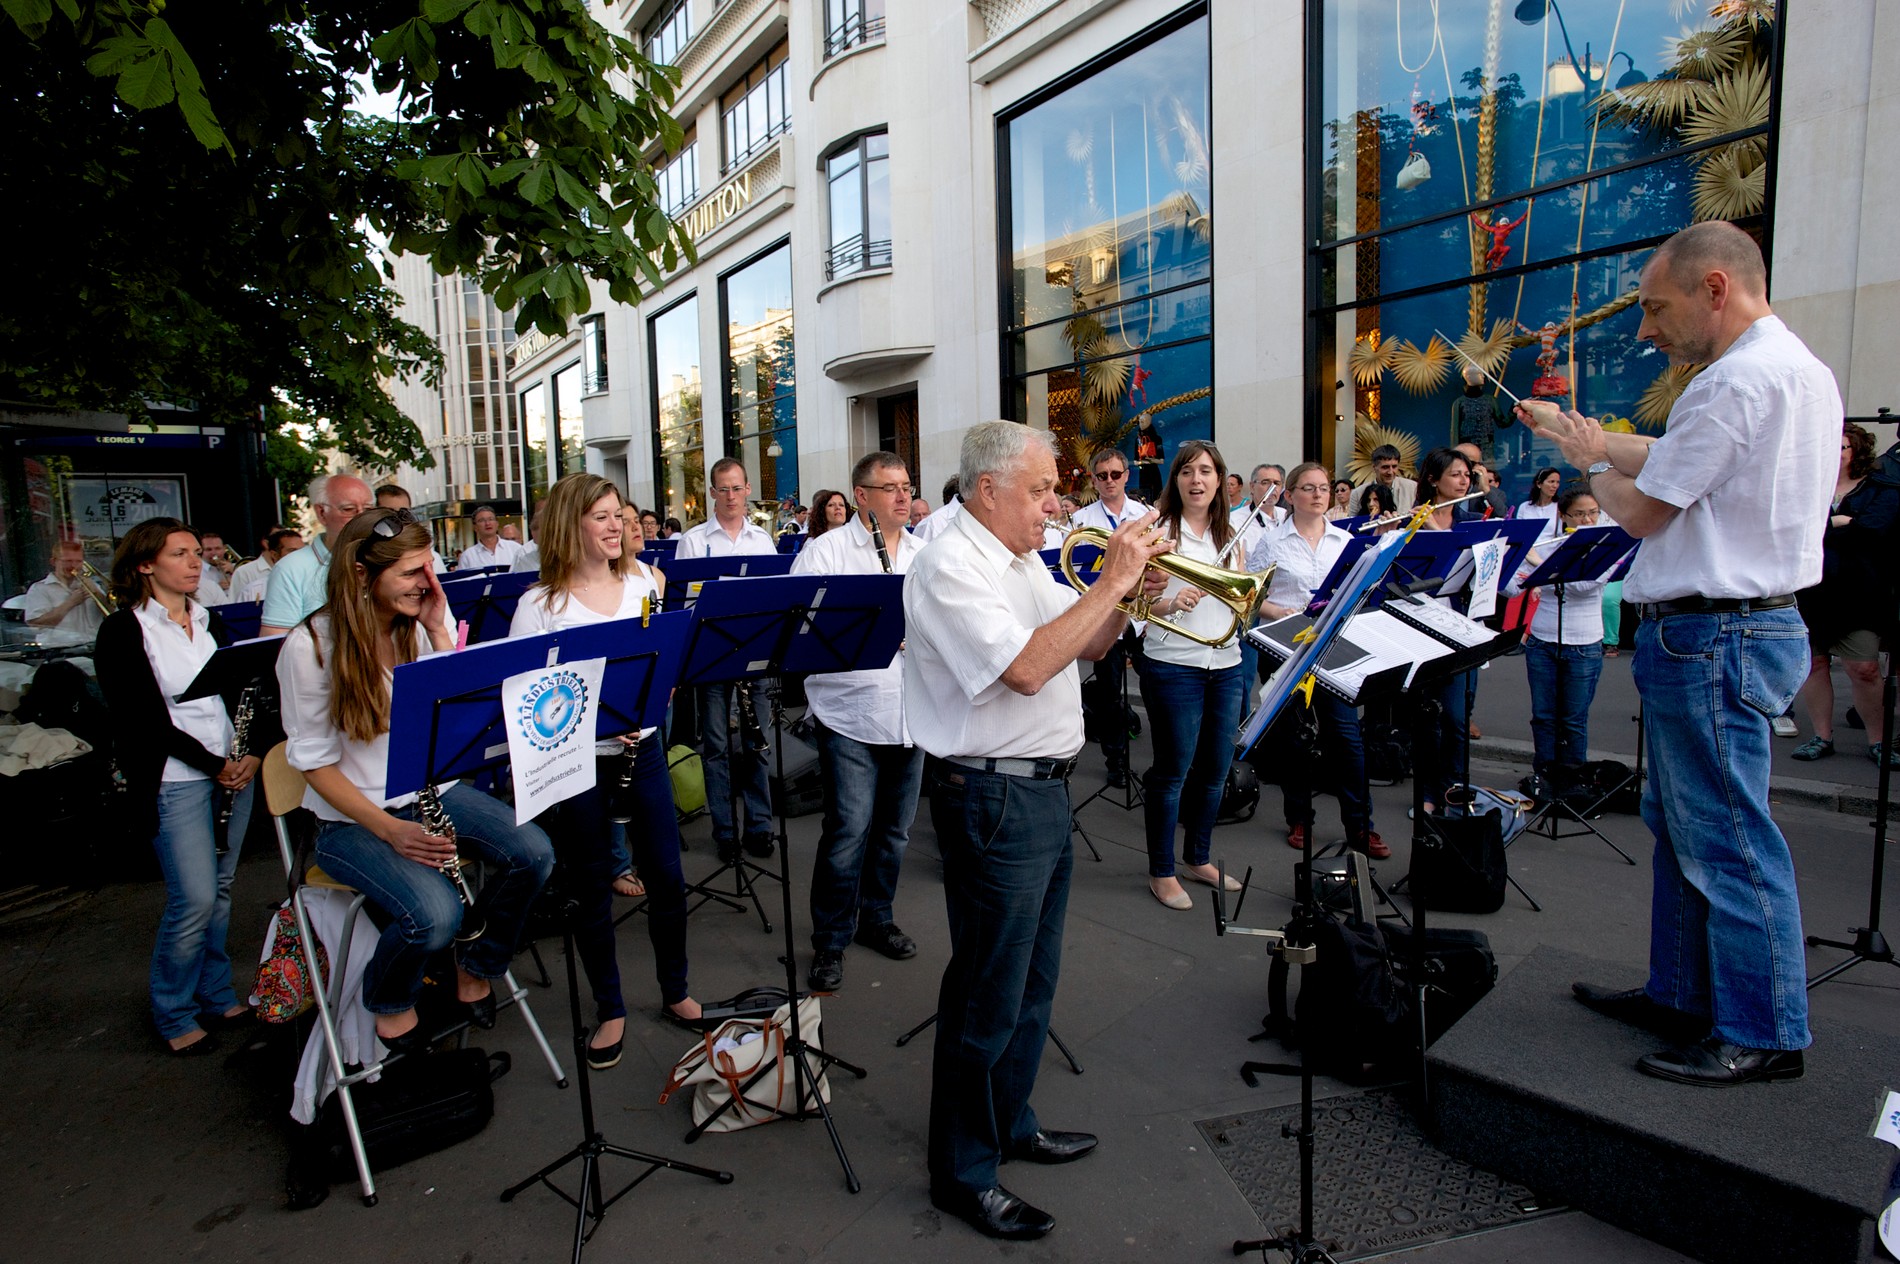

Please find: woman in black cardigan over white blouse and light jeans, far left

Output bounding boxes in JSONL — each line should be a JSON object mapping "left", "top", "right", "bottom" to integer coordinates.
{"left": 93, "top": 517, "right": 276, "bottom": 1057}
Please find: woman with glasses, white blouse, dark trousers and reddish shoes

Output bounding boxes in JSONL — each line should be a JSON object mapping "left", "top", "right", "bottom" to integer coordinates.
{"left": 1246, "top": 462, "right": 1393, "bottom": 859}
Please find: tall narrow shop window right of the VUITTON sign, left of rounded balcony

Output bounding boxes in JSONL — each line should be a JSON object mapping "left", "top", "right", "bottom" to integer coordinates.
{"left": 720, "top": 243, "right": 798, "bottom": 504}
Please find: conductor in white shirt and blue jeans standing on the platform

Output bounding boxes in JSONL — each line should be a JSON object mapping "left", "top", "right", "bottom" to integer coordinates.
{"left": 1520, "top": 220, "right": 1841, "bottom": 1085}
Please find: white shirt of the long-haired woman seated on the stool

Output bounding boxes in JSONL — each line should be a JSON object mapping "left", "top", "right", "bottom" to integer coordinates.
{"left": 277, "top": 614, "right": 454, "bottom": 821}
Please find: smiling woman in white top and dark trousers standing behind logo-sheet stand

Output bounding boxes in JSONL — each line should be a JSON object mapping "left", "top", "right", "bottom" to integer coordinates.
{"left": 509, "top": 473, "right": 699, "bottom": 1070}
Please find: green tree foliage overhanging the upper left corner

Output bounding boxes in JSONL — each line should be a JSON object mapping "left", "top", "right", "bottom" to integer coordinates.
{"left": 0, "top": 0, "right": 692, "bottom": 468}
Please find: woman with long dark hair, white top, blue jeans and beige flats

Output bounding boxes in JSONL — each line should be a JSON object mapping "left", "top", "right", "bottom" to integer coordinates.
{"left": 1138, "top": 439, "right": 1246, "bottom": 909}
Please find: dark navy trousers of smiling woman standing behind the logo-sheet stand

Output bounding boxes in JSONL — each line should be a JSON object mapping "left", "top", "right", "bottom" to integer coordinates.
{"left": 534, "top": 734, "right": 688, "bottom": 1026}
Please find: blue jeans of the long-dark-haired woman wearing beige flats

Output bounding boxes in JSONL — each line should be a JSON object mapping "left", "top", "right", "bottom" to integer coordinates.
{"left": 1142, "top": 656, "right": 1246, "bottom": 878}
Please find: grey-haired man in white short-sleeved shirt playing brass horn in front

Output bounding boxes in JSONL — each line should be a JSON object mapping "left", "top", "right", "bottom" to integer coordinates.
{"left": 904, "top": 422, "right": 1169, "bottom": 1239}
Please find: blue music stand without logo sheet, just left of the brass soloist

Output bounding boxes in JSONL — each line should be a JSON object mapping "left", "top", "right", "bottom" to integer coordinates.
{"left": 680, "top": 574, "right": 904, "bottom": 1194}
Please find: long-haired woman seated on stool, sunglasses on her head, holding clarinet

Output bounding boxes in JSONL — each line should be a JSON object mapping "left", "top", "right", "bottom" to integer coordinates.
{"left": 277, "top": 509, "right": 555, "bottom": 1053}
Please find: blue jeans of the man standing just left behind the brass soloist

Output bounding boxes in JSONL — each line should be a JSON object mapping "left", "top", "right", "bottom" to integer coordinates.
{"left": 811, "top": 724, "right": 923, "bottom": 952}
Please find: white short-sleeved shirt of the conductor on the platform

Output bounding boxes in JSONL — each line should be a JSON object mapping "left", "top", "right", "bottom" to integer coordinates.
{"left": 1623, "top": 316, "right": 1841, "bottom": 603}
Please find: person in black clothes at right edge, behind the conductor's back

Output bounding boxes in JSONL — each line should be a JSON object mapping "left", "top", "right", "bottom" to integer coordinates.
{"left": 1794, "top": 422, "right": 1900, "bottom": 768}
